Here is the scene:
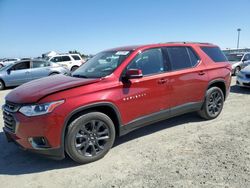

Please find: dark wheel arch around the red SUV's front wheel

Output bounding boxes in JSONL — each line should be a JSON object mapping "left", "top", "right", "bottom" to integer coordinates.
{"left": 61, "top": 102, "right": 121, "bottom": 148}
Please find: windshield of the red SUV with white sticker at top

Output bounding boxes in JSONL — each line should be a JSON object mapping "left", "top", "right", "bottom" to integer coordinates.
{"left": 72, "top": 51, "right": 131, "bottom": 78}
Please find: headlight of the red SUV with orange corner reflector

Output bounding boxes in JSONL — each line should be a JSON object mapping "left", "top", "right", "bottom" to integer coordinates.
{"left": 19, "top": 100, "right": 64, "bottom": 116}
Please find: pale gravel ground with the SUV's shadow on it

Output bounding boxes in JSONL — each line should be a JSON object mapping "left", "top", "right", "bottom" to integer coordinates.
{"left": 0, "top": 79, "right": 250, "bottom": 188}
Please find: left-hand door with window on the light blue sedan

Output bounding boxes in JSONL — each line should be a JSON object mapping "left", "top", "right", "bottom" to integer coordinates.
{"left": 7, "top": 61, "right": 31, "bottom": 86}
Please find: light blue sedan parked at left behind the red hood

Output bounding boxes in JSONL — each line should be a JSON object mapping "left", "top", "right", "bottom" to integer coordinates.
{"left": 0, "top": 59, "right": 70, "bottom": 90}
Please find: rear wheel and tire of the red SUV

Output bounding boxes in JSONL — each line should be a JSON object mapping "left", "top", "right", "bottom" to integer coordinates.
{"left": 198, "top": 87, "right": 224, "bottom": 120}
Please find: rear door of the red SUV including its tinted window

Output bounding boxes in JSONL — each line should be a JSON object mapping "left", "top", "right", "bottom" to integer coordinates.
{"left": 163, "top": 46, "right": 208, "bottom": 109}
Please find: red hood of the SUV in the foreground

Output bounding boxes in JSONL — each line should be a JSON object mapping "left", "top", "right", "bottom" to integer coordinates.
{"left": 5, "top": 75, "right": 100, "bottom": 103}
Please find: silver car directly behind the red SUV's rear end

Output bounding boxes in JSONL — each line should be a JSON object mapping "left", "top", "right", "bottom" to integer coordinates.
{"left": 225, "top": 53, "right": 250, "bottom": 75}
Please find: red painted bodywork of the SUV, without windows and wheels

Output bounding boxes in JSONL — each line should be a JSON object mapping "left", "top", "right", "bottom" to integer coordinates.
{"left": 3, "top": 43, "right": 231, "bottom": 153}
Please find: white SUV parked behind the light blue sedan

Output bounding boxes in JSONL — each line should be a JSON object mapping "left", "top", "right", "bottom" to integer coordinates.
{"left": 46, "top": 54, "right": 84, "bottom": 72}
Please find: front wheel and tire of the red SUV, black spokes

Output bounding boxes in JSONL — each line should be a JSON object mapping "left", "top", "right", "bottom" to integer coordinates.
{"left": 65, "top": 112, "right": 115, "bottom": 164}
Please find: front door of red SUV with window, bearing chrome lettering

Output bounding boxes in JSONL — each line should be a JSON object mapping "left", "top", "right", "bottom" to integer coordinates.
{"left": 119, "top": 48, "right": 168, "bottom": 124}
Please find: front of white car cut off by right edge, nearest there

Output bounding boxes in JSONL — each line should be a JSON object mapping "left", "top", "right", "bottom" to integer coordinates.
{"left": 236, "top": 65, "right": 250, "bottom": 88}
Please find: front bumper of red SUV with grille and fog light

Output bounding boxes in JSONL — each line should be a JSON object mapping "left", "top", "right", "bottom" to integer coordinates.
{"left": 3, "top": 110, "right": 65, "bottom": 159}
